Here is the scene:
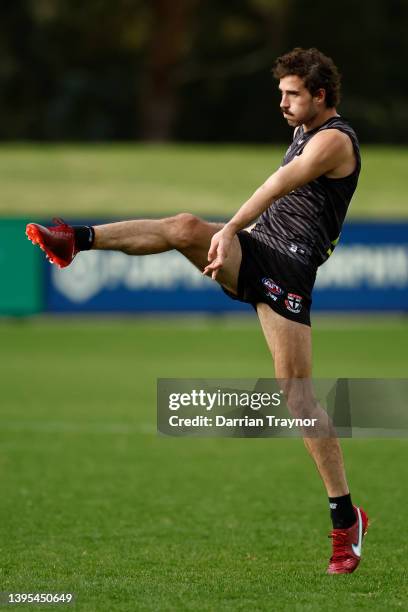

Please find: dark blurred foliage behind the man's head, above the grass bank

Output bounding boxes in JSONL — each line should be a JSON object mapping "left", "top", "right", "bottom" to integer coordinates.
{"left": 0, "top": 0, "right": 408, "bottom": 144}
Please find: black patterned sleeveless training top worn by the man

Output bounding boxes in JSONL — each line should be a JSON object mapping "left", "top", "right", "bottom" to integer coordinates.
{"left": 251, "top": 116, "right": 361, "bottom": 267}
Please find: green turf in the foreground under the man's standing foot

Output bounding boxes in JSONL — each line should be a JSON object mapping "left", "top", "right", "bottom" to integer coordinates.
{"left": 0, "top": 318, "right": 408, "bottom": 612}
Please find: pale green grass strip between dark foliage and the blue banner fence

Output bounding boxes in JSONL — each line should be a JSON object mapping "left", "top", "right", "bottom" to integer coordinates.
{"left": 0, "top": 144, "right": 408, "bottom": 218}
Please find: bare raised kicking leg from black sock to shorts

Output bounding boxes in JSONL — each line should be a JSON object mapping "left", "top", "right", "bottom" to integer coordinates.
{"left": 93, "top": 213, "right": 242, "bottom": 293}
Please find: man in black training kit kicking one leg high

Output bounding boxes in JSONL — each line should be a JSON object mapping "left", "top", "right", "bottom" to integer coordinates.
{"left": 27, "top": 48, "right": 368, "bottom": 574}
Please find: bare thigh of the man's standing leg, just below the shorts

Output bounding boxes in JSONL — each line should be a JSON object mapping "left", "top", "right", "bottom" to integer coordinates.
{"left": 257, "top": 303, "right": 312, "bottom": 379}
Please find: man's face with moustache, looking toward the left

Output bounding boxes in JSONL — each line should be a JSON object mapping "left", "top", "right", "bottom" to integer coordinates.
{"left": 279, "top": 75, "right": 324, "bottom": 127}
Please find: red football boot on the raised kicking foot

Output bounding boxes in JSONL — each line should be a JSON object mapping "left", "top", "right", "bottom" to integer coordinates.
{"left": 26, "top": 219, "right": 78, "bottom": 268}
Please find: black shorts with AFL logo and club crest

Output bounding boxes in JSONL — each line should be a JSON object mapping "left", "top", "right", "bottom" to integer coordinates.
{"left": 224, "top": 230, "right": 316, "bottom": 326}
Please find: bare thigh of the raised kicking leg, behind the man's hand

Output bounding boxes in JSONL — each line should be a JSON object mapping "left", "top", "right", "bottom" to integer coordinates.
{"left": 180, "top": 220, "right": 242, "bottom": 294}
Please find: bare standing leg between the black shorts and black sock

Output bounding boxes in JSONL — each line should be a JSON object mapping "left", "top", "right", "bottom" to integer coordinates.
{"left": 257, "top": 304, "right": 349, "bottom": 497}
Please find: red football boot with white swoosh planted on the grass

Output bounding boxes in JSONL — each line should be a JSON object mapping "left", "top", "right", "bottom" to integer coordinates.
{"left": 327, "top": 506, "right": 368, "bottom": 574}
